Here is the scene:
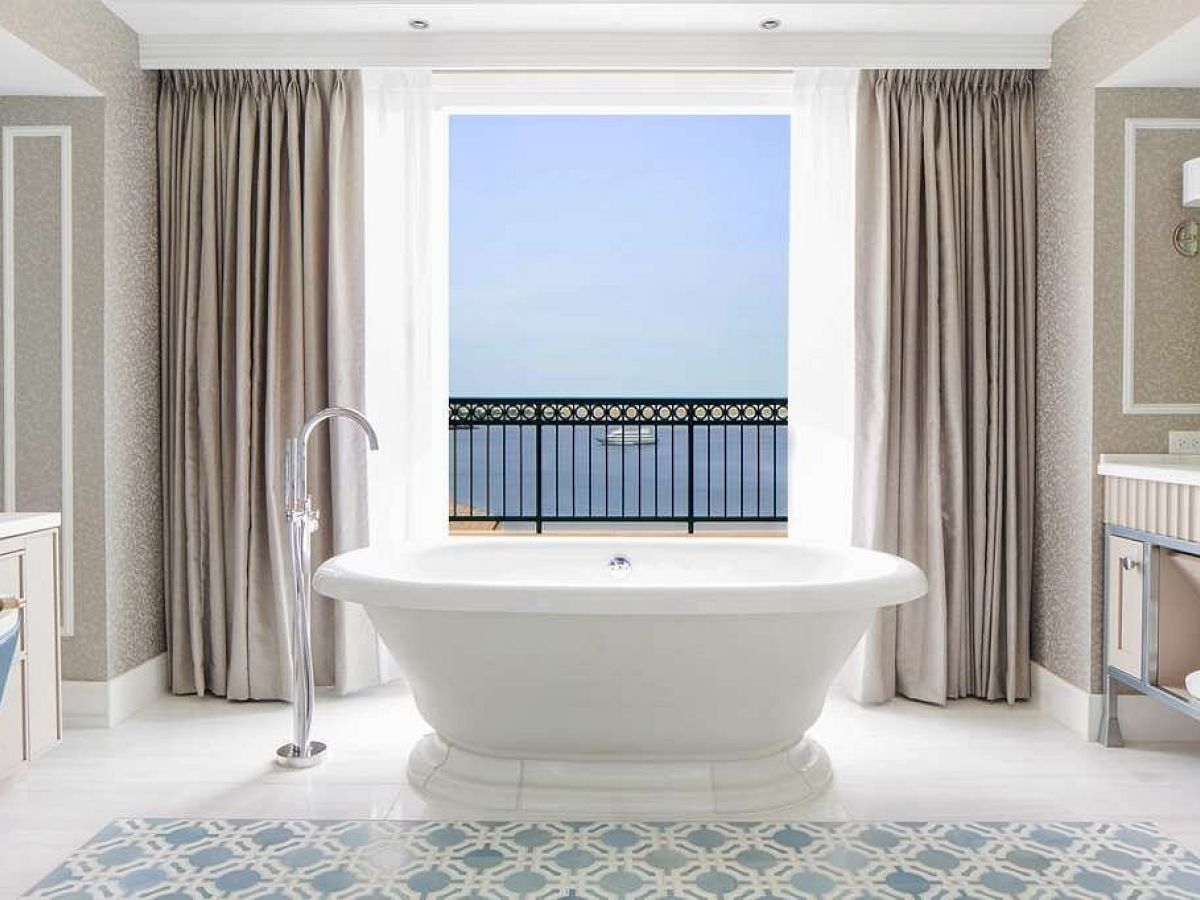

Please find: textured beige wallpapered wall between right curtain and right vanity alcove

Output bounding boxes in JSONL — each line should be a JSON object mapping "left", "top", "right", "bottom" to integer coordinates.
{"left": 1032, "top": 0, "right": 1200, "bottom": 689}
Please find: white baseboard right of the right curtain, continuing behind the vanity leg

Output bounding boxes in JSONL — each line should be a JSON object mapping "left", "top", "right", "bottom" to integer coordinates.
{"left": 1030, "top": 662, "right": 1200, "bottom": 742}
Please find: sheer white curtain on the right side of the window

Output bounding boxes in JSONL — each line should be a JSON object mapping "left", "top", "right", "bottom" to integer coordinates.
{"left": 787, "top": 68, "right": 859, "bottom": 544}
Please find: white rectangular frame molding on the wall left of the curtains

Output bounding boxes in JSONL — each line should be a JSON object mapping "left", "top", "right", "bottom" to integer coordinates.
{"left": 0, "top": 125, "right": 74, "bottom": 637}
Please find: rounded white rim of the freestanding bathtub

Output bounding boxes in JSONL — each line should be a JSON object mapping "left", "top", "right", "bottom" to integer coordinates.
{"left": 313, "top": 536, "right": 929, "bottom": 616}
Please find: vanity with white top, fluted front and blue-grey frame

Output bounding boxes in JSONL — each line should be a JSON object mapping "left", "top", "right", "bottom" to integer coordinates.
{"left": 1099, "top": 456, "right": 1200, "bottom": 746}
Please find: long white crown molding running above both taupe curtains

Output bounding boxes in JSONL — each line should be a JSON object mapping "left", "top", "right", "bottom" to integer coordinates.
{"left": 139, "top": 32, "right": 1050, "bottom": 68}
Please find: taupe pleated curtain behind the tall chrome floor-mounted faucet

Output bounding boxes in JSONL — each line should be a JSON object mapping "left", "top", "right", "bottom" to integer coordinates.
{"left": 158, "top": 71, "right": 377, "bottom": 700}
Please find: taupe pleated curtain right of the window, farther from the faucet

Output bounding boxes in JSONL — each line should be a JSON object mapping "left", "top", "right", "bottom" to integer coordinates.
{"left": 854, "top": 71, "right": 1037, "bottom": 703}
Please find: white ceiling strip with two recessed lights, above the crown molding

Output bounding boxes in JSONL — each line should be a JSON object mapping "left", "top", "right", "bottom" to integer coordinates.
{"left": 104, "top": 0, "right": 1082, "bottom": 36}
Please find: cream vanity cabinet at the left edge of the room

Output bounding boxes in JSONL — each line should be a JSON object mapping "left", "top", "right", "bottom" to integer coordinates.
{"left": 0, "top": 517, "right": 62, "bottom": 778}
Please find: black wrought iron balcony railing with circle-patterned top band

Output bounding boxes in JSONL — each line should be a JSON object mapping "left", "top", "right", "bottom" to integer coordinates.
{"left": 449, "top": 397, "right": 787, "bottom": 532}
